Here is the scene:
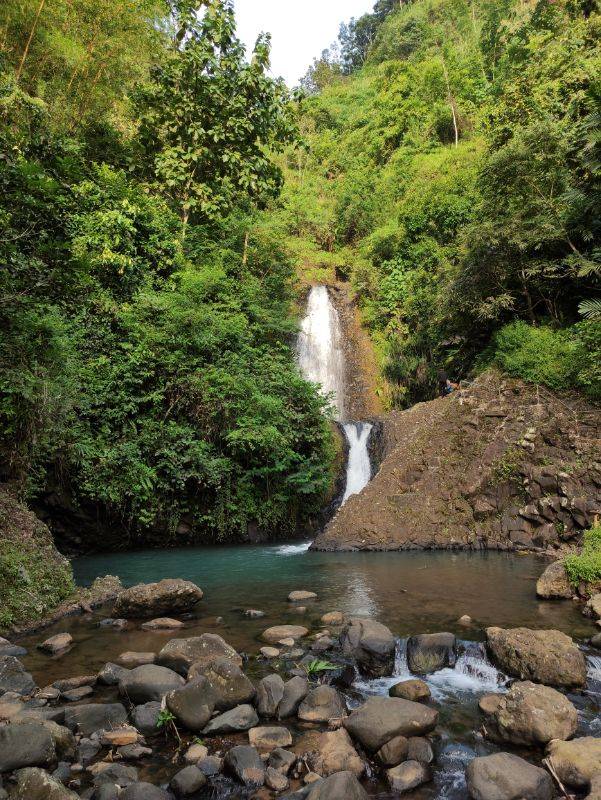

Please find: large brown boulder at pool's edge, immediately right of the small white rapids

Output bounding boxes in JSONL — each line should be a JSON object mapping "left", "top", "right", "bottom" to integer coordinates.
{"left": 486, "top": 628, "right": 586, "bottom": 687}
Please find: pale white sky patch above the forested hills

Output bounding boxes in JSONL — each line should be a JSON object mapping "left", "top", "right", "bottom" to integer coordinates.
{"left": 234, "top": 0, "right": 374, "bottom": 87}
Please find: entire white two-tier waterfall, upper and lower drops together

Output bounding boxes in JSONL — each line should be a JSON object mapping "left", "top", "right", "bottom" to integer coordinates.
{"left": 297, "top": 286, "right": 373, "bottom": 505}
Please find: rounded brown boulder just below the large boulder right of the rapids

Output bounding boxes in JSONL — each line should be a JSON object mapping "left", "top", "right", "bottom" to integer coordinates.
{"left": 486, "top": 681, "right": 578, "bottom": 746}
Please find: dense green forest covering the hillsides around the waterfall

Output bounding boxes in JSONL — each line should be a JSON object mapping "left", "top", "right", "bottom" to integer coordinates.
{"left": 0, "top": 0, "right": 601, "bottom": 542}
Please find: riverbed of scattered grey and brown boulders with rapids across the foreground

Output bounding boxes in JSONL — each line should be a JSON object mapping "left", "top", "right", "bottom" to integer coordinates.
{"left": 0, "top": 579, "right": 601, "bottom": 800}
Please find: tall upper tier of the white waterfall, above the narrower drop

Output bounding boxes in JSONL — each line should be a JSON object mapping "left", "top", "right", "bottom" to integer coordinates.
{"left": 298, "top": 286, "right": 344, "bottom": 419}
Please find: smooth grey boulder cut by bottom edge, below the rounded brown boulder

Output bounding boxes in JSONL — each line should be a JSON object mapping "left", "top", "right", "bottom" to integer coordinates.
{"left": 466, "top": 753, "right": 555, "bottom": 800}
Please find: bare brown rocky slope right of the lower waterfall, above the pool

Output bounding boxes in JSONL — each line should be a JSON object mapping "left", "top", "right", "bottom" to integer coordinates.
{"left": 313, "top": 371, "right": 601, "bottom": 550}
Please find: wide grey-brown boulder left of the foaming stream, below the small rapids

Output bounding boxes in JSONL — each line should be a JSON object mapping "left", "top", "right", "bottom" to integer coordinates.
{"left": 343, "top": 697, "right": 438, "bottom": 752}
